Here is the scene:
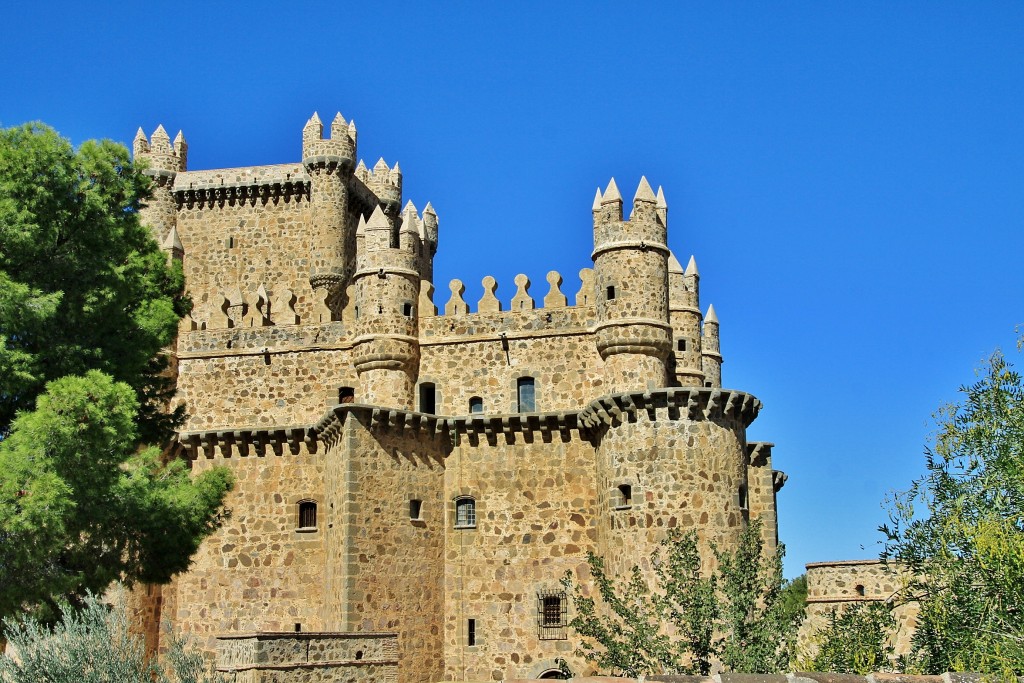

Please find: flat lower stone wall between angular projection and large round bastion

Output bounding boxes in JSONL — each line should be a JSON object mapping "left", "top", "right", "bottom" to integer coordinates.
{"left": 443, "top": 431, "right": 601, "bottom": 680}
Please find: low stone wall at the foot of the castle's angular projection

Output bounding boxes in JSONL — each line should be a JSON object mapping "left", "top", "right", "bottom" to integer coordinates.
{"left": 217, "top": 633, "right": 398, "bottom": 683}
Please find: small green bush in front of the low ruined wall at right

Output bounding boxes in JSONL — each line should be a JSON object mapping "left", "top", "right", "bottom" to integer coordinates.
{"left": 799, "top": 602, "right": 896, "bottom": 675}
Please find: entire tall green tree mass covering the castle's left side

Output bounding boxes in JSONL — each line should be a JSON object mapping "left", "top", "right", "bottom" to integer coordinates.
{"left": 0, "top": 124, "right": 231, "bottom": 618}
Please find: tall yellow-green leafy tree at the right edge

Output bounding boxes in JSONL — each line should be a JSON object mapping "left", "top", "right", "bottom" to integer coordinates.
{"left": 881, "top": 342, "right": 1024, "bottom": 676}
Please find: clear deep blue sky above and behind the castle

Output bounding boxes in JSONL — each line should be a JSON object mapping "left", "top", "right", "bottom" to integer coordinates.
{"left": 0, "top": 2, "right": 1024, "bottom": 577}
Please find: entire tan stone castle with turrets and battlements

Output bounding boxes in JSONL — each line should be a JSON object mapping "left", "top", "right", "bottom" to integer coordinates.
{"left": 134, "top": 114, "right": 785, "bottom": 683}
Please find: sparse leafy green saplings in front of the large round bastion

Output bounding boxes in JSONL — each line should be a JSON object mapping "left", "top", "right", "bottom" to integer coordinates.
{"left": 563, "top": 520, "right": 802, "bottom": 677}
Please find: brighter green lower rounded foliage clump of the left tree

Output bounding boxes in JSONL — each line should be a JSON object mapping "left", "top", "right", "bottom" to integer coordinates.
{"left": 0, "top": 371, "right": 230, "bottom": 616}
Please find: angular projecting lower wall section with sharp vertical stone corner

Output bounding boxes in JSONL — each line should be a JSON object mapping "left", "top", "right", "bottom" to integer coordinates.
{"left": 325, "top": 411, "right": 445, "bottom": 683}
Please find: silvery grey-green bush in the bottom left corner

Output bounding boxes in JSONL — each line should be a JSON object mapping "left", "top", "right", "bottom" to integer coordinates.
{"left": 0, "top": 595, "right": 226, "bottom": 683}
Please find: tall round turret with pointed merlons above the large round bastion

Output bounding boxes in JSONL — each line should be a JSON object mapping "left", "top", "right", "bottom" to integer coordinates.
{"left": 593, "top": 178, "right": 672, "bottom": 391}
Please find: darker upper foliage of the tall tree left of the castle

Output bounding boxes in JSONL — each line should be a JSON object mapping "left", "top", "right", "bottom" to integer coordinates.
{"left": 0, "top": 124, "right": 189, "bottom": 442}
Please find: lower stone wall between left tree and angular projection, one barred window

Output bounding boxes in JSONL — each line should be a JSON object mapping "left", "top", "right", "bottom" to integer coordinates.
{"left": 164, "top": 449, "right": 332, "bottom": 652}
